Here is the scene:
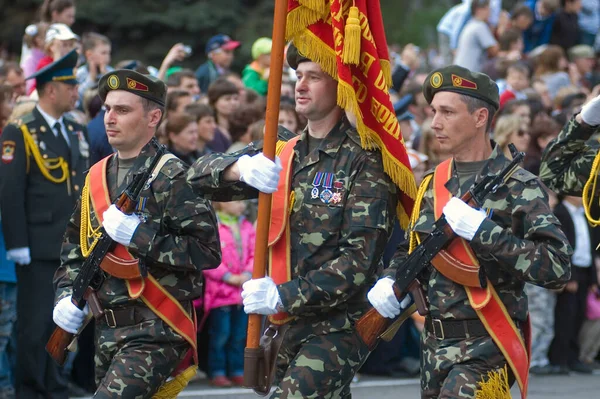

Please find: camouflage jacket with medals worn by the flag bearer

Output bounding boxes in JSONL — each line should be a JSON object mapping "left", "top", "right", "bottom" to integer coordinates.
{"left": 188, "top": 119, "right": 397, "bottom": 332}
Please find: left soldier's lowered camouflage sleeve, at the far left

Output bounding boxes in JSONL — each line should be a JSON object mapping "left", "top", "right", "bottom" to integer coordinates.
{"left": 54, "top": 198, "right": 84, "bottom": 303}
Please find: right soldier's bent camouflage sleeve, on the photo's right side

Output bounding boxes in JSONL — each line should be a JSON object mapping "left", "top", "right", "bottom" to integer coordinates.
{"left": 471, "top": 179, "right": 573, "bottom": 289}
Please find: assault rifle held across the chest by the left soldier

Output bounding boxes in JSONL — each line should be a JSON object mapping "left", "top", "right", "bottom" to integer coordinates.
{"left": 46, "top": 144, "right": 166, "bottom": 366}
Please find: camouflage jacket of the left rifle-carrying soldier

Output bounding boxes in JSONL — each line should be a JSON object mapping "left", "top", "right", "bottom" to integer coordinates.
{"left": 54, "top": 139, "right": 221, "bottom": 307}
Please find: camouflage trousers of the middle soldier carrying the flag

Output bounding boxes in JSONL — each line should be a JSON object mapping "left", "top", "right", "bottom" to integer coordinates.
{"left": 271, "top": 325, "right": 369, "bottom": 399}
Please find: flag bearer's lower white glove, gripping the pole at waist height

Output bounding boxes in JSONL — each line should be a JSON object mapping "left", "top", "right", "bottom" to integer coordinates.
{"left": 242, "top": 277, "right": 282, "bottom": 315}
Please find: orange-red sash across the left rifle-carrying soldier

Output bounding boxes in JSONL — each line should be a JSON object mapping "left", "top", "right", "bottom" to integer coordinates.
{"left": 86, "top": 155, "right": 198, "bottom": 363}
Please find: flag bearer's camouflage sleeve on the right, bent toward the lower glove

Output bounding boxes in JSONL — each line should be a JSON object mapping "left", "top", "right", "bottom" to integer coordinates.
{"left": 278, "top": 153, "right": 397, "bottom": 314}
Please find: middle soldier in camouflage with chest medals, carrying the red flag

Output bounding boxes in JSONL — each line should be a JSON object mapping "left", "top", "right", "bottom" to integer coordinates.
{"left": 188, "top": 46, "right": 397, "bottom": 398}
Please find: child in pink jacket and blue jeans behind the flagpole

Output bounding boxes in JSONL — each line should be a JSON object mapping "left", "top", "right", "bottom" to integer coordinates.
{"left": 204, "top": 201, "right": 256, "bottom": 387}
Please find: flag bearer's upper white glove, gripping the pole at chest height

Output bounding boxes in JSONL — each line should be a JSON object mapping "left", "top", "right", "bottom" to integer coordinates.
{"left": 237, "top": 152, "right": 282, "bottom": 194}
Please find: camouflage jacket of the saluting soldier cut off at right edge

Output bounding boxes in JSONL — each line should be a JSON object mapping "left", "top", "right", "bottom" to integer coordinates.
{"left": 540, "top": 117, "right": 600, "bottom": 197}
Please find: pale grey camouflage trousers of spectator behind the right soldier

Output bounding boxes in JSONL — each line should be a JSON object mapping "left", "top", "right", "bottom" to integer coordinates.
{"left": 525, "top": 284, "right": 556, "bottom": 367}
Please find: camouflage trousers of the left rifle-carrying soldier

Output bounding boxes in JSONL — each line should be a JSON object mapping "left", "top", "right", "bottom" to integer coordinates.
{"left": 94, "top": 319, "right": 189, "bottom": 399}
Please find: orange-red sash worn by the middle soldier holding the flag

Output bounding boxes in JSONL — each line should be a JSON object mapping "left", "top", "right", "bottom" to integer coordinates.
{"left": 268, "top": 136, "right": 300, "bottom": 325}
